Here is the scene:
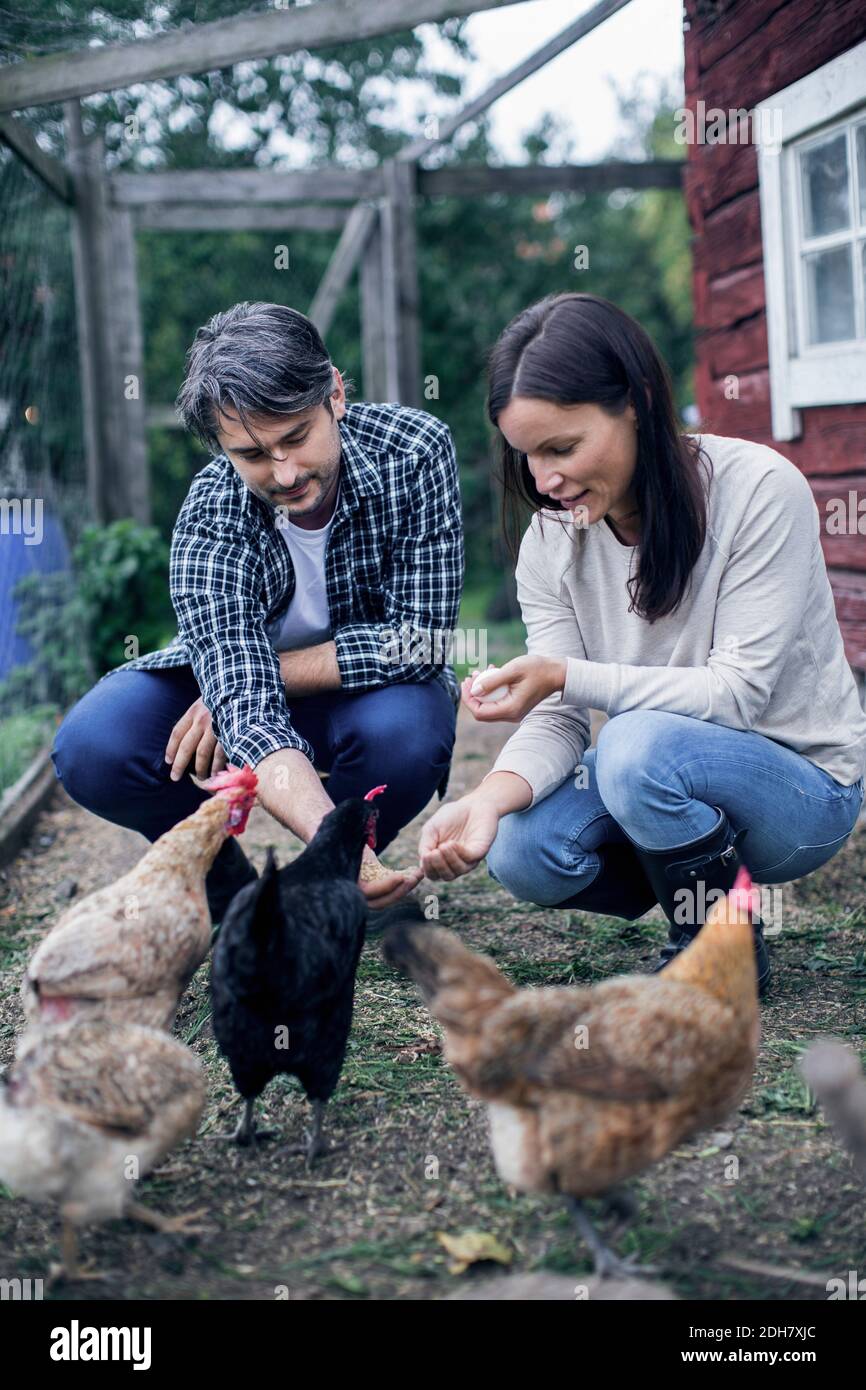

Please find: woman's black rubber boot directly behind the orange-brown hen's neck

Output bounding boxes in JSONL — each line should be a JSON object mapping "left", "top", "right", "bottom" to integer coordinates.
{"left": 625, "top": 806, "right": 770, "bottom": 995}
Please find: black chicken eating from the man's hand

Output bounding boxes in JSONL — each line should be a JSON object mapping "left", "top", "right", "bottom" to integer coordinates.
{"left": 211, "top": 788, "right": 382, "bottom": 1166}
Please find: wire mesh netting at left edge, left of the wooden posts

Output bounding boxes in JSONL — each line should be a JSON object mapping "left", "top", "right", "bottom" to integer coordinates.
{"left": 0, "top": 147, "right": 89, "bottom": 750}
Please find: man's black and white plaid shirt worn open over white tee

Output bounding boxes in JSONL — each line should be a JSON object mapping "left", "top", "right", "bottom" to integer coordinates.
{"left": 101, "top": 404, "right": 464, "bottom": 767}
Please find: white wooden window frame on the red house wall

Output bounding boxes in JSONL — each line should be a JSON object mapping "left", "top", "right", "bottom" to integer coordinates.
{"left": 755, "top": 42, "right": 866, "bottom": 439}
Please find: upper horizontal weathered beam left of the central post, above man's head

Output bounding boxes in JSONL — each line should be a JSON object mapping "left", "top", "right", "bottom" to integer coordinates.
{"left": 110, "top": 166, "right": 382, "bottom": 207}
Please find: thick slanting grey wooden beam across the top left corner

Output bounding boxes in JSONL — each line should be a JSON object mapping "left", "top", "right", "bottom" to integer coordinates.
{"left": 0, "top": 0, "right": 525, "bottom": 111}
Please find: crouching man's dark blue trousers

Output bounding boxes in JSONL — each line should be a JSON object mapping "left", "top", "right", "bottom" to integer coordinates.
{"left": 51, "top": 666, "right": 456, "bottom": 872}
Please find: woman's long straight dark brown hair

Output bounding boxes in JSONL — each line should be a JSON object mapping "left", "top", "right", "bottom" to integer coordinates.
{"left": 488, "top": 295, "right": 712, "bottom": 623}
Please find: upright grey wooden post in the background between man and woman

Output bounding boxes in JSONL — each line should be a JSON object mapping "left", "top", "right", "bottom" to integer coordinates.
{"left": 381, "top": 160, "right": 421, "bottom": 406}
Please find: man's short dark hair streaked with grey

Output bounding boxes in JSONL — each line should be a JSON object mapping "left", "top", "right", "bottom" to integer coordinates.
{"left": 177, "top": 303, "right": 334, "bottom": 453}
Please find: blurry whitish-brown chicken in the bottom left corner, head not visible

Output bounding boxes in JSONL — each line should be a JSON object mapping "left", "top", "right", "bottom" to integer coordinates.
{"left": 0, "top": 1020, "right": 204, "bottom": 1279}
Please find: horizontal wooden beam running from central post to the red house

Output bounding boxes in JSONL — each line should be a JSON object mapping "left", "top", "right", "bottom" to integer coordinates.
{"left": 418, "top": 160, "right": 685, "bottom": 197}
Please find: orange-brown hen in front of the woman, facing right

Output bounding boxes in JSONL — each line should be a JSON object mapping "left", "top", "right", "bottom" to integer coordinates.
{"left": 384, "top": 870, "right": 759, "bottom": 1276}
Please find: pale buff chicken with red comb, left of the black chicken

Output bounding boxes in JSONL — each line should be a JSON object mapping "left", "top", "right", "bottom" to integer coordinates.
{"left": 22, "top": 767, "right": 256, "bottom": 1029}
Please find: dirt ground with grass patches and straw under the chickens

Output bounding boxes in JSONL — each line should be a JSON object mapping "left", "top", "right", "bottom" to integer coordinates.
{"left": 0, "top": 712, "right": 866, "bottom": 1300}
